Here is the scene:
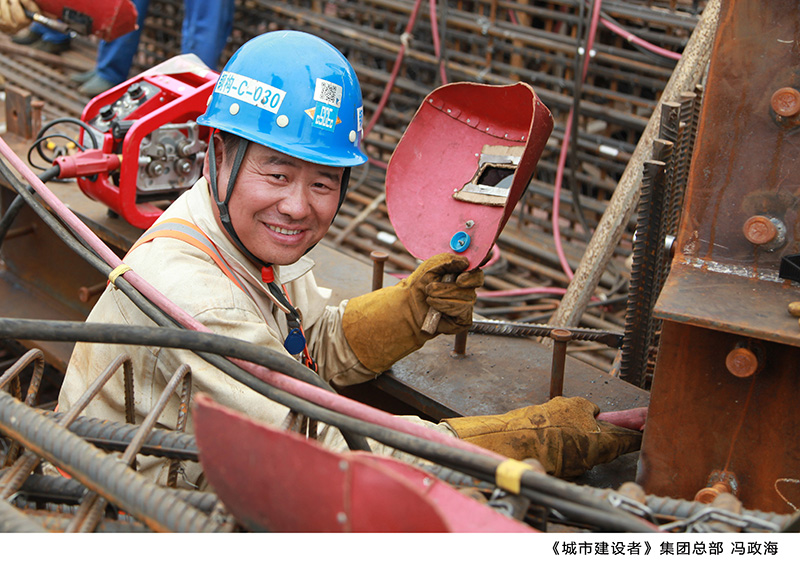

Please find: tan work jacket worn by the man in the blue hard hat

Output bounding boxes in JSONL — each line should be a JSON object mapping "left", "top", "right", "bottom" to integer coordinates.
{"left": 59, "top": 179, "right": 446, "bottom": 480}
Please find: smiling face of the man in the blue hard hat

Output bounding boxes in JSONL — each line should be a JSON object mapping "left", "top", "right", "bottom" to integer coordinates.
{"left": 206, "top": 138, "right": 343, "bottom": 265}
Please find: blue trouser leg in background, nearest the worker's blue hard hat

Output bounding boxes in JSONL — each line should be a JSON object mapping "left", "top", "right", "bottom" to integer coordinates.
{"left": 181, "top": 0, "right": 234, "bottom": 70}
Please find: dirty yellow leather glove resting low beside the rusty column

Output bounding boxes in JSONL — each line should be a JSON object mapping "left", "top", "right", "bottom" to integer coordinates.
{"left": 442, "top": 396, "right": 642, "bottom": 478}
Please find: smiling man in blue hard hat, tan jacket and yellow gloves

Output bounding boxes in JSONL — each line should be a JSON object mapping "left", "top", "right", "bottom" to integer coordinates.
{"left": 59, "top": 31, "right": 640, "bottom": 486}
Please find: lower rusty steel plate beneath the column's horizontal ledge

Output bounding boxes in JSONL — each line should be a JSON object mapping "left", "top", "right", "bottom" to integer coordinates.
{"left": 637, "top": 321, "right": 800, "bottom": 513}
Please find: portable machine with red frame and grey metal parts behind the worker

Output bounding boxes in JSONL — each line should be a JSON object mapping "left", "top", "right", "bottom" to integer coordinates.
{"left": 76, "top": 55, "right": 219, "bottom": 229}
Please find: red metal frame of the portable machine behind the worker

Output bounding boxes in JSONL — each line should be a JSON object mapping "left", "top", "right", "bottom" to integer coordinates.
{"left": 78, "top": 57, "right": 219, "bottom": 229}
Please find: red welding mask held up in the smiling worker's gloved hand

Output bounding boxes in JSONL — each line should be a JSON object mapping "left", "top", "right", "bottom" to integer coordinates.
{"left": 386, "top": 83, "right": 553, "bottom": 268}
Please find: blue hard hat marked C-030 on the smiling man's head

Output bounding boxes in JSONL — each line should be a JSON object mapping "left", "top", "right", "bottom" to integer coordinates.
{"left": 197, "top": 31, "right": 367, "bottom": 168}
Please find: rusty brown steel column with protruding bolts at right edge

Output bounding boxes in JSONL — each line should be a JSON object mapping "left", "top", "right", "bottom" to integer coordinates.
{"left": 637, "top": 0, "right": 800, "bottom": 513}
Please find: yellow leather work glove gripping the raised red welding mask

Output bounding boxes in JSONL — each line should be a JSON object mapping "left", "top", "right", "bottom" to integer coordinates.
{"left": 342, "top": 254, "right": 483, "bottom": 373}
